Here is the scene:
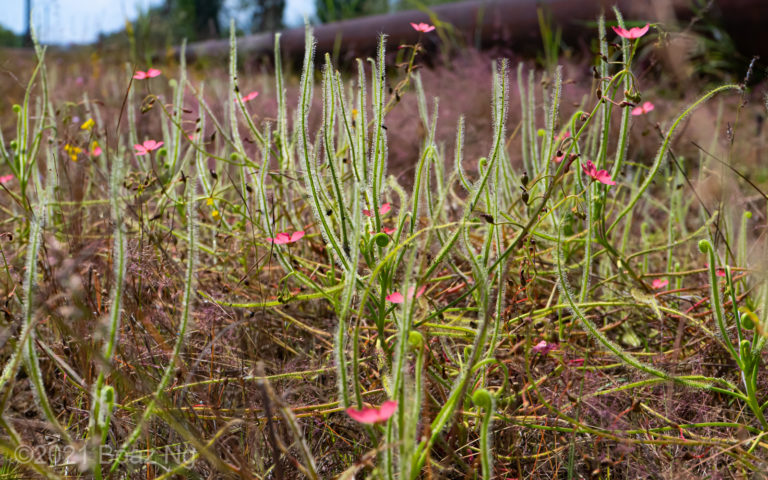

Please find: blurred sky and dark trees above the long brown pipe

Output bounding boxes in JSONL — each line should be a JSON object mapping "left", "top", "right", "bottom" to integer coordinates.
{"left": 0, "top": 0, "right": 462, "bottom": 46}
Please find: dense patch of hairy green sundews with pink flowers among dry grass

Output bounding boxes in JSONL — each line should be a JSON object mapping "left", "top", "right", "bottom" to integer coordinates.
{"left": 0, "top": 10, "right": 768, "bottom": 480}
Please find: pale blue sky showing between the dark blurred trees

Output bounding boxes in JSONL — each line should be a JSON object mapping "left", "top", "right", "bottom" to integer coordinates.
{"left": 0, "top": 0, "right": 315, "bottom": 45}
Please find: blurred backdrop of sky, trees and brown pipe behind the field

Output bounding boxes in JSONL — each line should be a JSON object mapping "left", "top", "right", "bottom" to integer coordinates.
{"left": 0, "top": 0, "right": 768, "bottom": 78}
